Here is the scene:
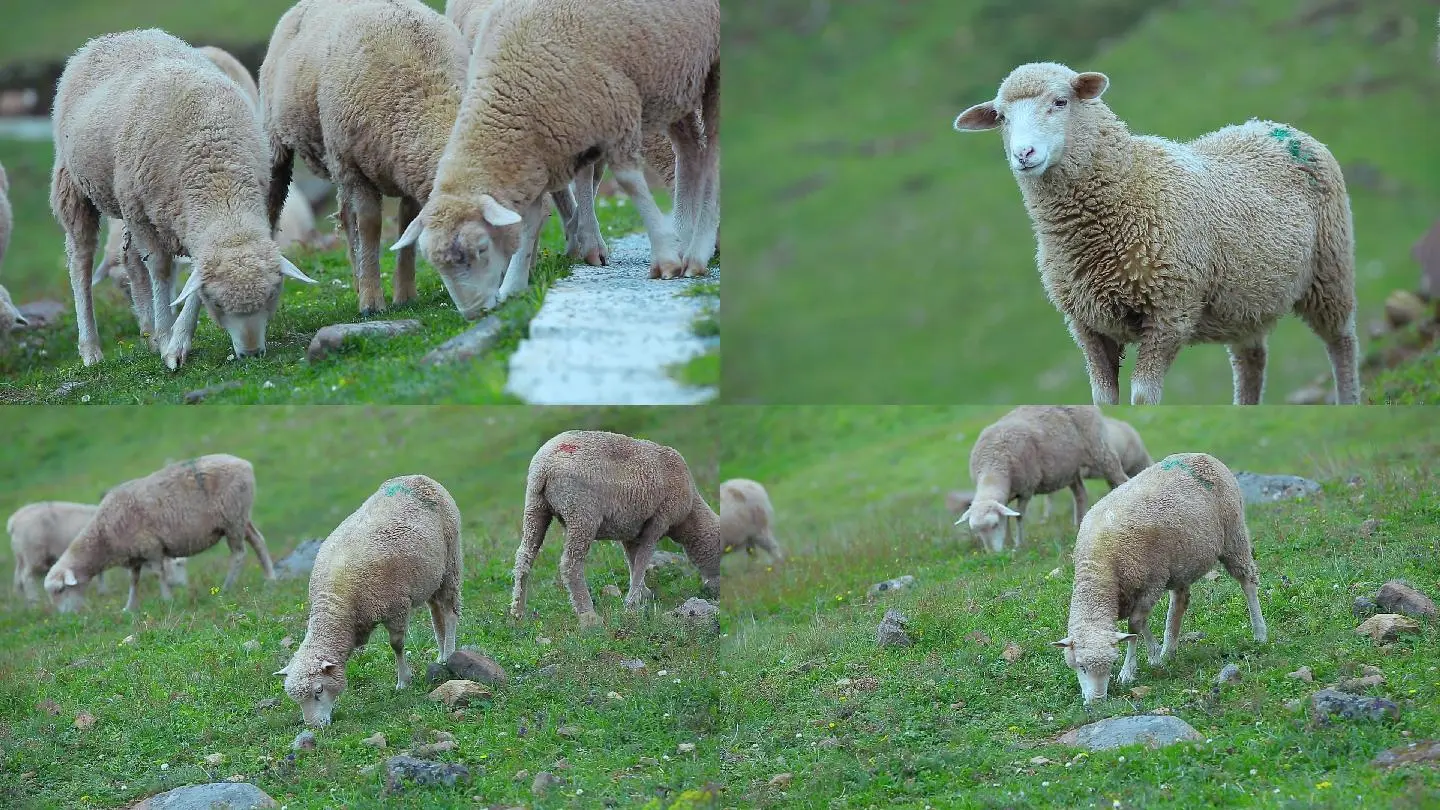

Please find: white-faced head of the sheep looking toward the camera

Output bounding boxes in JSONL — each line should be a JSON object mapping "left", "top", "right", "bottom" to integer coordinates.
{"left": 955, "top": 62, "right": 1110, "bottom": 177}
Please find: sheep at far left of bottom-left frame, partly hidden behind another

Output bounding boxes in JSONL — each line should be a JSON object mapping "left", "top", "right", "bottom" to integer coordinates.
{"left": 6, "top": 500, "right": 187, "bottom": 602}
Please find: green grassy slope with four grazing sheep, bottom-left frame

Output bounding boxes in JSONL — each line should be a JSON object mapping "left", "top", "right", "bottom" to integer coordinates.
{"left": 0, "top": 406, "right": 719, "bottom": 809}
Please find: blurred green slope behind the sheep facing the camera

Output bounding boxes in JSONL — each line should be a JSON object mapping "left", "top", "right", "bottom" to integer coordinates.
{"left": 724, "top": 0, "right": 1440, "bottom": 404}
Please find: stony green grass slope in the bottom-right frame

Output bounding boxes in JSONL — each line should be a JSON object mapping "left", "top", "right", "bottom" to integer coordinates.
{"left": 719, "top": 406, "right": 1440, "bottom": 809}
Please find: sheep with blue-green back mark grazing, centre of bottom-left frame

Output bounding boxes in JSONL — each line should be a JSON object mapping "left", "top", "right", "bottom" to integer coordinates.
{"left": 275, "top": 476, "right": 461, "bottom": 726}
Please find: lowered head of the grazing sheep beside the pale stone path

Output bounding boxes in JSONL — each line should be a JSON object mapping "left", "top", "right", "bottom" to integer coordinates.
{"left": 390, "top": 195, "right": 521, "bottom": 320}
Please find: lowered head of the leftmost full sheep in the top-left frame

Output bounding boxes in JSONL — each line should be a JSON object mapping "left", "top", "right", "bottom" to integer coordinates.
{"left": 170, "top": 235, "right": 315, "bottom": 357}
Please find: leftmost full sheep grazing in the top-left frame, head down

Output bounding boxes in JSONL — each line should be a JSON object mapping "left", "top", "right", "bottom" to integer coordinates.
{"left": 50, "top": 29, "right": 314, "bottom": 370}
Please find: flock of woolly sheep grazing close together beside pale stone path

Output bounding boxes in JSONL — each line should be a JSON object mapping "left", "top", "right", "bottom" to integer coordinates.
{"left": 0, "top": 0, "right": 720, "bottom": 369}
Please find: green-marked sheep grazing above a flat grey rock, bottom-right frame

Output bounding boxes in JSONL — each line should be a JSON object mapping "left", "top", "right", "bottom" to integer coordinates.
{"left": 1051, "top": 453, "right": 1269, "bottom": 703}
